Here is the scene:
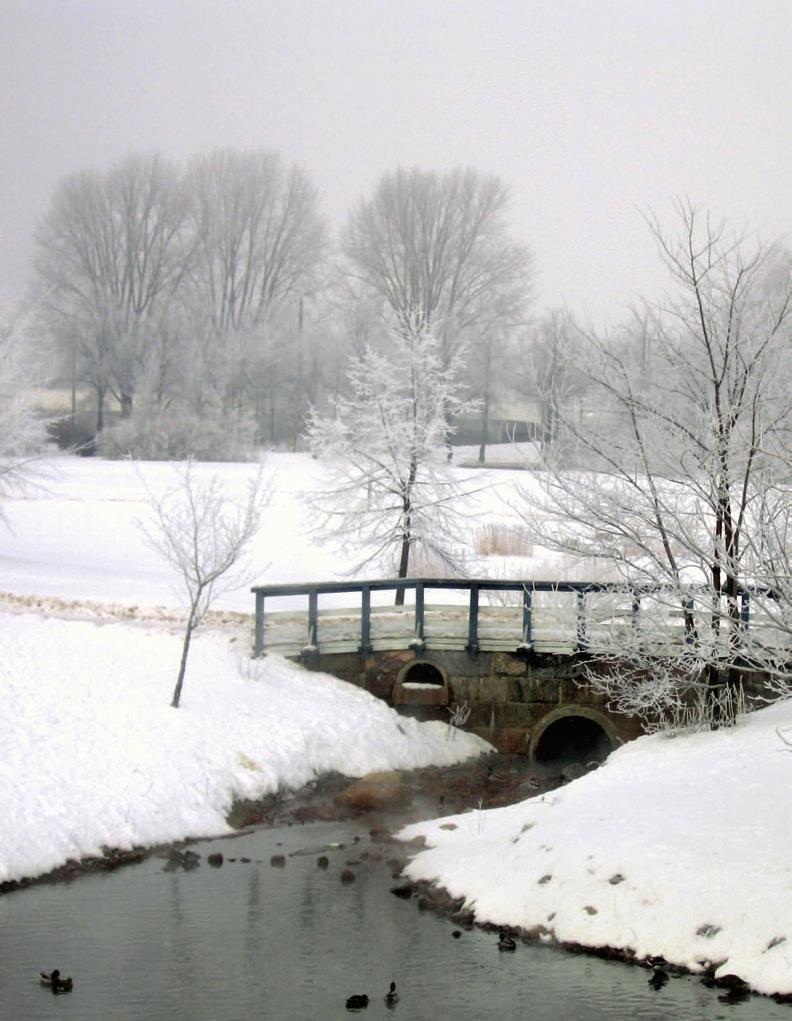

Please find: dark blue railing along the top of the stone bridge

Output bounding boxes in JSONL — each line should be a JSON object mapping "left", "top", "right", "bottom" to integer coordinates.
{"left": 251, "top": 578, "right": 787, "bottom": 657}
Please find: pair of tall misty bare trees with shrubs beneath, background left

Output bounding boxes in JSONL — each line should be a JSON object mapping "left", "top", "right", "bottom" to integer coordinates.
{"left": 33, "top": 150, "right": 325, "bottom": 457}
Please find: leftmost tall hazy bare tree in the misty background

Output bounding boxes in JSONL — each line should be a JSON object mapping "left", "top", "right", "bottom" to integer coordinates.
{"left": 35, "top": 156, "right": 190, "bottom": 432}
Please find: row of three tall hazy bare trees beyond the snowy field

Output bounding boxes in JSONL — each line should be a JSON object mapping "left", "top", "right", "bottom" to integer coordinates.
{"left": 33, "top": 149, "right": 533, "bottom": 457}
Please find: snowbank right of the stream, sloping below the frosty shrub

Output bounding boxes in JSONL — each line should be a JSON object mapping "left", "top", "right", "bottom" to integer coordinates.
{"left": 399, "top": 702, "right": 792, "bottom": 993}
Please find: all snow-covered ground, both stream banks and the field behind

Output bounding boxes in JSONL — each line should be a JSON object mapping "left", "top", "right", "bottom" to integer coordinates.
{"left": 0, "top": 454, "right": 792, "bottom": 992}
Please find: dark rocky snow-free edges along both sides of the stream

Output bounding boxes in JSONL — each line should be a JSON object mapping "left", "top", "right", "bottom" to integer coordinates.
{"left": 3, "top": 756, "right": 792, "bottom": 1004}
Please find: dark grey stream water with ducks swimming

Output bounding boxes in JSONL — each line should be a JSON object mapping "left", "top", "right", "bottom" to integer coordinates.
{"left": 0, "top": 823, "right": 792, "bottom": 1021}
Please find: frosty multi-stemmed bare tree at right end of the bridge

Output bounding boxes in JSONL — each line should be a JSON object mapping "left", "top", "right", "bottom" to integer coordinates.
{"left": 526, "top": 203, "right": 792, "bottom": 725}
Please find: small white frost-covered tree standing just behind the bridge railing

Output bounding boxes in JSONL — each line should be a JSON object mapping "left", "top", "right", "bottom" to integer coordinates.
{"left": 307, "top": 323, "right": 473, "bottom": 602}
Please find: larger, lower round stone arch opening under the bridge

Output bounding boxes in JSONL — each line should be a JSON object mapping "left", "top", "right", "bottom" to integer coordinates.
{"left": 528, "top": 706, "right": 622, "bottom": 762}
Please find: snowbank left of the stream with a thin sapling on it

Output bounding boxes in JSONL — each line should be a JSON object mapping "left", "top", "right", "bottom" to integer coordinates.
{"left": 0, "top": 613, "right": 489, "bottom": 881}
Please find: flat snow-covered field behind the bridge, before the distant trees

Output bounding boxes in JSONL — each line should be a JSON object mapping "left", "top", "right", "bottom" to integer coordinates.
{"left": 0, "top": 454, "right": 592, "bottom": 613}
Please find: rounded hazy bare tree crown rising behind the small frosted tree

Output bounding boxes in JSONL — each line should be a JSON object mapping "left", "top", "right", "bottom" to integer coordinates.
{"left": 342, "top": 167, "right": 531, "bottom": 362}
